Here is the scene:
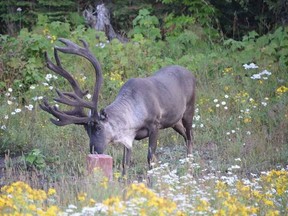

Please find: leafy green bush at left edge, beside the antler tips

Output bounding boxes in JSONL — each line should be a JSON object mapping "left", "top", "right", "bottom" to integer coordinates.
{"left": 0, "top": 29, "right": 51, "bottom": 95}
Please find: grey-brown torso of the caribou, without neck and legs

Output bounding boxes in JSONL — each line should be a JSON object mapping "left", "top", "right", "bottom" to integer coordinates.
{"left": 112, "top": 65, "right": 195, "bottom": 128}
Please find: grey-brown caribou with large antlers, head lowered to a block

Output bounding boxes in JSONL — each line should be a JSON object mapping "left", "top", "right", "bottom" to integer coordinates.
{"left": 40, "top": 38, "right": 196, "bottom": 174}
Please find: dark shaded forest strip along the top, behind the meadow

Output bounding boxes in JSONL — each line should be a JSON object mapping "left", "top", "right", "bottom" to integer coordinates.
{"left": 0, "top": 0, "right": 288, "bottom": 39}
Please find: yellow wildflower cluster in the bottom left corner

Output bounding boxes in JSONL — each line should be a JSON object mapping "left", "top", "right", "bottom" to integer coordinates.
{"left": 0, "top": 181, "right": 59, "bottom": 215}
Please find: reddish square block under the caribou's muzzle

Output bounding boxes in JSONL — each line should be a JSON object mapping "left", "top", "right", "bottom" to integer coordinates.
{"left": 87, "top": 154, "right": 113, "bottom": 181}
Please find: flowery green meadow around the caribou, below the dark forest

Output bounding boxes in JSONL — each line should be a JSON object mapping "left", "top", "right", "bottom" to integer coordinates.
{"left": 0, "top": 22, "right": 288, "bottom": 215}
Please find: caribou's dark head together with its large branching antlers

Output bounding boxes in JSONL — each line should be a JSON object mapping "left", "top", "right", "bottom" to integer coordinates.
{"left": 40, "top": 38, "right": 108, "bottom": 154}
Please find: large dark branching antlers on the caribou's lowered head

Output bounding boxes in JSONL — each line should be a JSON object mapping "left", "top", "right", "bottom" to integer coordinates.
{"left": 40, "top": 38, "right": 103, "bottom": 126}
